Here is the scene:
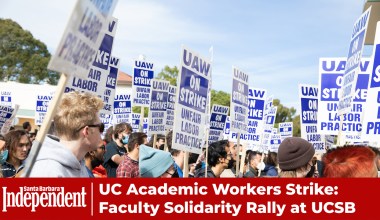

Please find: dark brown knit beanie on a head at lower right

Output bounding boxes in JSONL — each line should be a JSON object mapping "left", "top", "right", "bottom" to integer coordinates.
{"left": 277, "top": 137, "right": 315, "bottom": 170}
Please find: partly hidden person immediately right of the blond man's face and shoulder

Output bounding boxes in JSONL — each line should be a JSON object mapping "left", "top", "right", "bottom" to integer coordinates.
{"left": 84, "top": 140, "right": 106, "bottom": 177}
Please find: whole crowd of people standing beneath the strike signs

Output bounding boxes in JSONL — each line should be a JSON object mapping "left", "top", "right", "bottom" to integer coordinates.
{"left": 0, "top": 92, "right": 380, "bottom": 178}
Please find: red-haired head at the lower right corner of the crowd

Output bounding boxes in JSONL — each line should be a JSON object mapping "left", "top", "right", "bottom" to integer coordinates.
{"left": 322, "top": 145, "right": 378, "bottom": 178}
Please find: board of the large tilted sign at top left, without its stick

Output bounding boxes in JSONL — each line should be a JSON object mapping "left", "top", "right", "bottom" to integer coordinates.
{"left": 48, "top": 0, "right": 117, "bottom": 78}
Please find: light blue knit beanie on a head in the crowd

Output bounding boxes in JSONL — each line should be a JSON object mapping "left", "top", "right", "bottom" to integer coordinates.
{"left": 139, "top": 145, "right": 174, "bottom": 177}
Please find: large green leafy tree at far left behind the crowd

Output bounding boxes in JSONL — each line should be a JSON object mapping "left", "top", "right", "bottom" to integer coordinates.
{"left": 0, "top": 19, "right": 59, "bottom": 85}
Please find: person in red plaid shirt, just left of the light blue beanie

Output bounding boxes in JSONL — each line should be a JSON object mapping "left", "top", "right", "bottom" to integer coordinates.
{"left": 116, "top": 132, "right": 148, "bottom": 178}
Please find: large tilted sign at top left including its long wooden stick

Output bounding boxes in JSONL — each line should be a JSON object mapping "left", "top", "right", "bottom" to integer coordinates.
{"left": 23, "top": 0, "right": 119, "bottom": 177}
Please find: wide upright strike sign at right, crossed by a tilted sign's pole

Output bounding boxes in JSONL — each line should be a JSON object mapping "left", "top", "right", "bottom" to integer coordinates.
{"left": 317, "top": 58, "right": 370, "bottom": 142}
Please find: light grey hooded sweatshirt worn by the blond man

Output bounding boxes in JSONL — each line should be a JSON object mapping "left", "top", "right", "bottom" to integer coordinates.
{"left": 30, "top": 136, "right": 89, "bottom": 177}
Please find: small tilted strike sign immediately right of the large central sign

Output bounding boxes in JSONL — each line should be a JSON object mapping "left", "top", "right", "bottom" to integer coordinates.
{"left": 208, "top": 104, "right": 229, "bottom": 145}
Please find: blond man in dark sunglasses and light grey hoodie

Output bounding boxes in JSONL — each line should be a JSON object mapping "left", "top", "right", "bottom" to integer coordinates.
{"left": 30, "top": 91, "right": 104, "bottom": 177}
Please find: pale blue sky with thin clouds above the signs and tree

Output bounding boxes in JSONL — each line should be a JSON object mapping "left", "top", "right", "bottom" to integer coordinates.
{"left": 0, "top": 0, "right": 371, "bottom": 114}
